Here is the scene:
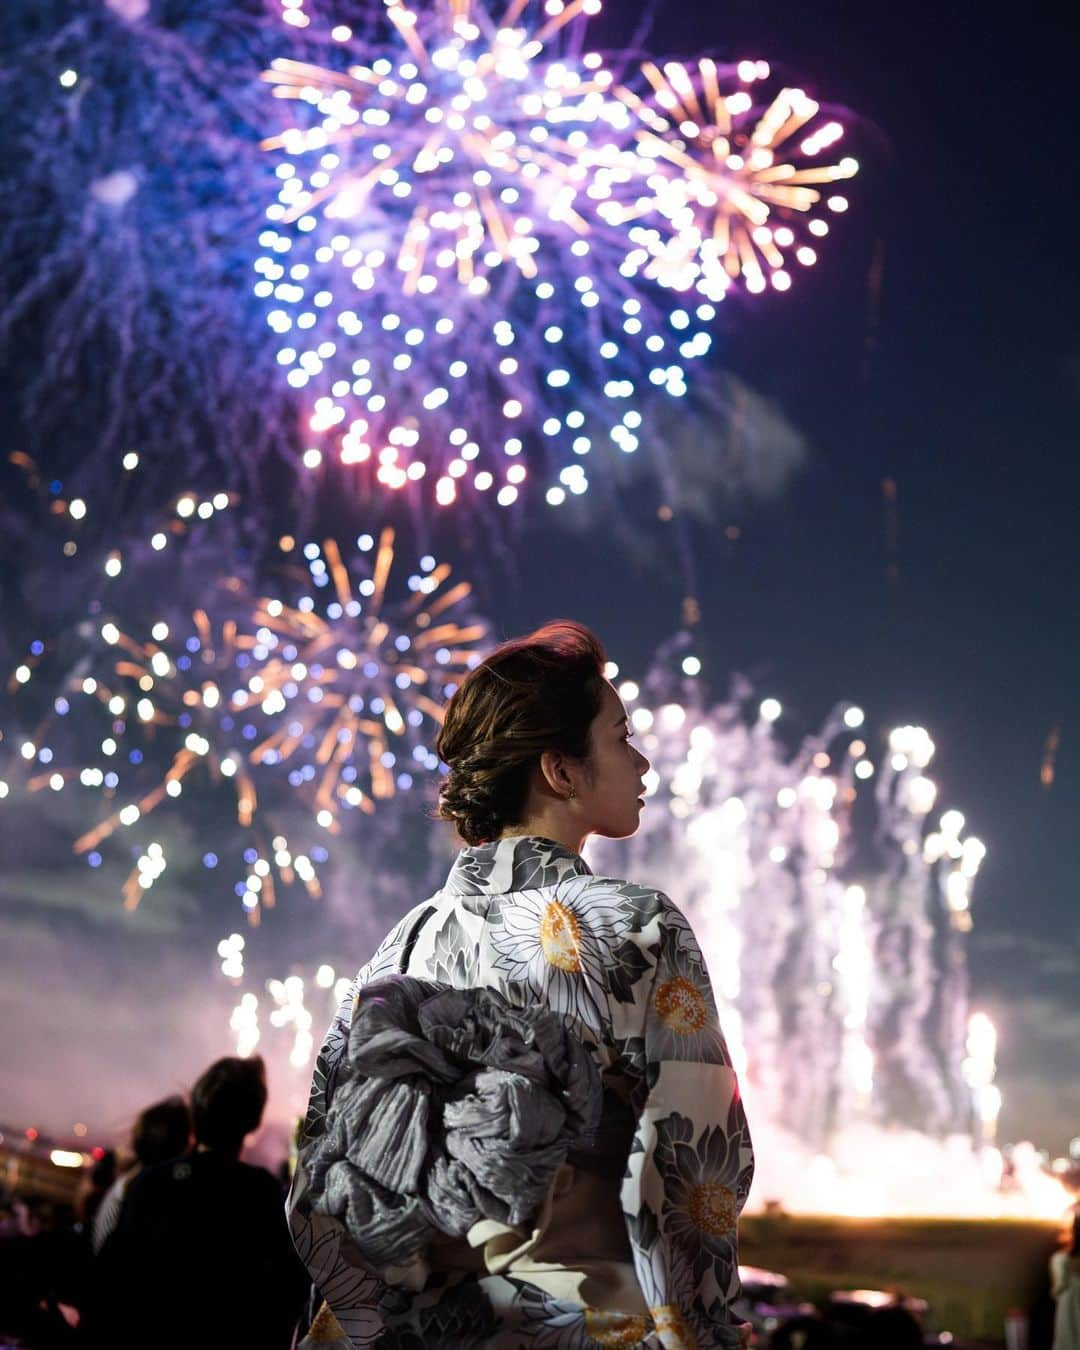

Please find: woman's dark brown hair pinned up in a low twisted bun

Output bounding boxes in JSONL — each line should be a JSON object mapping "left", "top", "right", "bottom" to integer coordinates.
{"left": 436, "top": 620, "right": 606, "bottom": 844}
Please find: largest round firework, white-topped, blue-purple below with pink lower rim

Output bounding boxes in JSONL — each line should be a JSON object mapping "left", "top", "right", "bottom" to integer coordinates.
{"left": 255, "top": 0, "right": 714, "bottom": 506}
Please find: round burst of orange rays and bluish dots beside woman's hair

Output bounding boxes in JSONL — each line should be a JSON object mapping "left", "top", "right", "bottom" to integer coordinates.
{"left": 232, "top": 529, "right": 486, "bottom": 830}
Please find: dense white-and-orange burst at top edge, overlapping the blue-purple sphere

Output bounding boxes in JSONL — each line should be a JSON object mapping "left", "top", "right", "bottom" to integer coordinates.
{"left": 263, "top": 0, "right": 615, "bottom": 296}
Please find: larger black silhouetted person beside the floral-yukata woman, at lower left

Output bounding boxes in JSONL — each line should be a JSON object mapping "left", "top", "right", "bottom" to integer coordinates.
{"left": 86, "top": 1058, "right": 308, "bottom": 1350}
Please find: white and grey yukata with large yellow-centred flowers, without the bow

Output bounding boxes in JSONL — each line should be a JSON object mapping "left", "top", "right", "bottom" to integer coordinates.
{"left": 288, "top": 837, "right": 753, "bottom": 1350}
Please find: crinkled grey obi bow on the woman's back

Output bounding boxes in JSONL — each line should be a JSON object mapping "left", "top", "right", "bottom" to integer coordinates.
{"left": 305, "top": 975, "right": 602, "bottom": 1289}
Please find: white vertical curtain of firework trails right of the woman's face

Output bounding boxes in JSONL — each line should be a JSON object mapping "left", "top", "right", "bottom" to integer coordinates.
{"left": 595, "top": 639, "right": 984, "bottom": 1146}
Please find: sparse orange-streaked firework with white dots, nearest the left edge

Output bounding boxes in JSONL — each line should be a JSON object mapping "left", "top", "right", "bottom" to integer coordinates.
{"left": 6, "top": 594, "right": 325, "bottom": 921}
